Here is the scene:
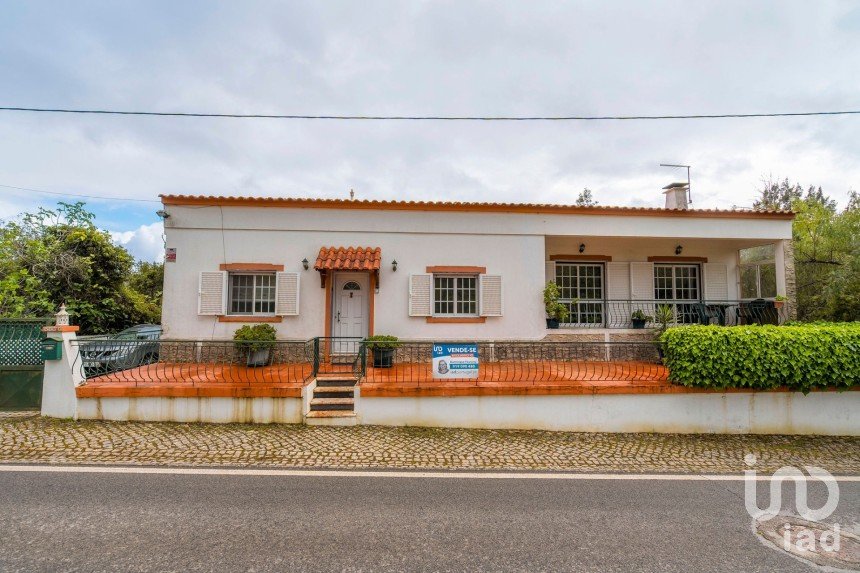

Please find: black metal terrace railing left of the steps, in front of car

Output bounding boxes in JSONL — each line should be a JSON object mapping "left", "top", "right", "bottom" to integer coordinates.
{"left": 72, "top": 337, "right": 316, "bottom": 385}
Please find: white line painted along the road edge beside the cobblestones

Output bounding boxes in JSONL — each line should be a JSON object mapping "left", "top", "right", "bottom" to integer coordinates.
{"left": 0, "top": 465, "right": 860, "bottom": 482}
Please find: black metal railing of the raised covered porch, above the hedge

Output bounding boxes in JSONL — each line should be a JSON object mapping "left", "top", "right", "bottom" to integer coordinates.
{"left": 561, "top": 299, "right": 789, "bottom": 328}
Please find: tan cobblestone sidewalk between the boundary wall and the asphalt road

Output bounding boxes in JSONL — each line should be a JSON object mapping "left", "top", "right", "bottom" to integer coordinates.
{"left": 0, "top": 413, "right": 860, "bottom": 475}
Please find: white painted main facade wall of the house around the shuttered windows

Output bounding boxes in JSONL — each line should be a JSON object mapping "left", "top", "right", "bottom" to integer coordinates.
{"left": 162, "top": 205, "right": 791, "bottom": 339}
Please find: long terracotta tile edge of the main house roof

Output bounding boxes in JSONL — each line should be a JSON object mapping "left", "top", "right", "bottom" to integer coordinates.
{"left": 159, "top": 195, "right": 794, "bottom": 219}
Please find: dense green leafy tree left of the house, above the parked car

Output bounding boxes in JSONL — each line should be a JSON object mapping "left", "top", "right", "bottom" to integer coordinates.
{"left": 0, "top": 202, "right": 159, "bottom": 333}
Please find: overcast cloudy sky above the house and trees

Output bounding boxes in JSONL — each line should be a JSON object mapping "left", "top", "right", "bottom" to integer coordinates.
{"left": 0, "top": 0, "right": 860, "bottom": 259}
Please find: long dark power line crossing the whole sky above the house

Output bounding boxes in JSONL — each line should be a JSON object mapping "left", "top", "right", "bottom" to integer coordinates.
{"left": 0, "top": 107, "right": 860, "bottom": 121}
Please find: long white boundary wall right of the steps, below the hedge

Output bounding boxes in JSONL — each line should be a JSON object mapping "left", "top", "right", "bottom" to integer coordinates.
{"left": 357, "top": 392, "right": 860, "bottom": 436}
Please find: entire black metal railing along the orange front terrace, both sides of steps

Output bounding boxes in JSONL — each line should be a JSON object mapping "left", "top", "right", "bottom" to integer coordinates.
{"left": 73, "top": 337, "right": 666, "bottom": 386}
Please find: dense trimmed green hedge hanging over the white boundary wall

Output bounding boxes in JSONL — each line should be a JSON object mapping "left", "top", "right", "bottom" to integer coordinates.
{"left": 661, "top": 322, "right": 860, "bottom": 393}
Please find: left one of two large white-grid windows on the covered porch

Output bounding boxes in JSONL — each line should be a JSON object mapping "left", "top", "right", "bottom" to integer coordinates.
{"left": 555, "top": 263, "right": 603, "bottom": 326}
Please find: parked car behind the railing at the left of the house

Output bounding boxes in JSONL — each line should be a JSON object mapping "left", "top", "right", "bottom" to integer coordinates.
{"left": 80, "top": 324, "right": 161, "bottom": 376}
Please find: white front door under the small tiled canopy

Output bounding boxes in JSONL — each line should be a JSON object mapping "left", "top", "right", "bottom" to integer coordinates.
{"left": 331, "top": 273, "right": 370, "bottom": 353}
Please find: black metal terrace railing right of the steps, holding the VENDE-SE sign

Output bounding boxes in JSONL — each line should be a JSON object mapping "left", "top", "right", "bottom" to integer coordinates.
{"left": 352, "top": 340, "right": 666, "bottom": 384}
